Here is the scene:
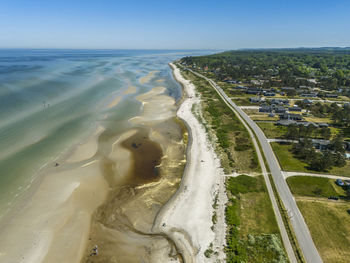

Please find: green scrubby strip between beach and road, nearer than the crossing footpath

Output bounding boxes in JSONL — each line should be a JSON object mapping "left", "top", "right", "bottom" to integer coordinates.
{"left": 226, "top": 175, "right": 288, "bottom": 262}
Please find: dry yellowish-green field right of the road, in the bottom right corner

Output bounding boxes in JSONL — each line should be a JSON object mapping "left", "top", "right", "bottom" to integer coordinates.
{"left": 297, "top": 201, "right": 350, "bottom": 263}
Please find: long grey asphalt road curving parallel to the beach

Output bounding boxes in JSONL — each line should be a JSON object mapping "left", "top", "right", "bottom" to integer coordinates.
{"left": 189, "top": 69, "right": 322, "bottom": 263}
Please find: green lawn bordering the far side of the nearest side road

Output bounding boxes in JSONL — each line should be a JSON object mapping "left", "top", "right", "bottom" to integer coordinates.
{"left": 271, "top": 142, "right": 350, "bottom": 177}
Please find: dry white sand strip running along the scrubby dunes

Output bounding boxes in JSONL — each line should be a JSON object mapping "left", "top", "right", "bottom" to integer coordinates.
{"left": 154, "top": 64, "right": 226, "bottom": 262}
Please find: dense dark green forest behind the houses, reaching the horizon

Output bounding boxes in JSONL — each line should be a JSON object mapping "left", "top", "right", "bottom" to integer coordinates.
{"left": 181, "top": 48, "right": 350, "bottom": 96}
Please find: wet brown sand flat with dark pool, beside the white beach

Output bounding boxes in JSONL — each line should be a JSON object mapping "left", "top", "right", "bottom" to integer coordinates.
{"left": 82, "top": 89, "right": 185, "bottom": 263}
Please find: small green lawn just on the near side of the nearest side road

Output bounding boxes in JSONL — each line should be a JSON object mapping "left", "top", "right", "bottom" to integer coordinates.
{"left": 287, "top": 176, "right": 345, "bottom": 198}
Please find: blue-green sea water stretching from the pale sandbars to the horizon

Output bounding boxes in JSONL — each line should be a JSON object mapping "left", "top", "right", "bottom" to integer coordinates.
{"left": 0, "top": 49, "right": 213, "bottom": 219}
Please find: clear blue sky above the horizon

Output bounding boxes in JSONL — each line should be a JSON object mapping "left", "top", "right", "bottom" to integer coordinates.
{"left": 0, "top": 0, "right": 350, "bottom": 50}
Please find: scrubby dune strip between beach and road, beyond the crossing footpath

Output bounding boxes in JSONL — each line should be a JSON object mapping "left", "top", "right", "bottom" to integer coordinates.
{"left": 182, "top": 68, "right": 260, "bottom": 174}
